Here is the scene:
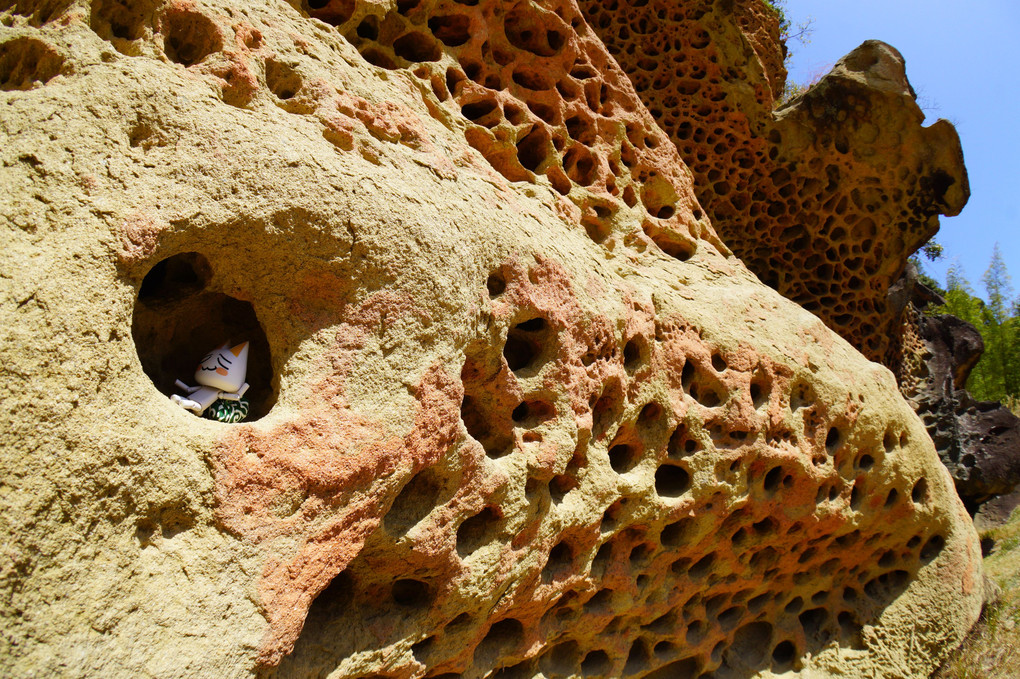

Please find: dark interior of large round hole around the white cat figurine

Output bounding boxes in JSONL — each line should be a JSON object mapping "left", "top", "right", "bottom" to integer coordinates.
{"left": 132, "top": 252, "right": 277, "bottom": 422}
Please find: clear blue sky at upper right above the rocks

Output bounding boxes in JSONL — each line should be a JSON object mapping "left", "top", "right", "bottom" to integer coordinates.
{"left": 785, "top": 0, "right": 1020, "bottom": 297}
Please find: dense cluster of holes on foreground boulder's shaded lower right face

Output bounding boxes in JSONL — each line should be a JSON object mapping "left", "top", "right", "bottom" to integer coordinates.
{"left": 277, "top": 269, "right": 947, "bottom": 679}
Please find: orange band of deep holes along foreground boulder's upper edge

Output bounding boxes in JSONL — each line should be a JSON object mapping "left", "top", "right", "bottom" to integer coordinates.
{"left": 302, "top": 0, "right": 697, "bottom": 260}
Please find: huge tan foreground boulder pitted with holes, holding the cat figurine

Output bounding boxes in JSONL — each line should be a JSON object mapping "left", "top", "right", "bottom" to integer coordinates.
{"left": 0, "top": 0, "right": 982, "bottom": 678}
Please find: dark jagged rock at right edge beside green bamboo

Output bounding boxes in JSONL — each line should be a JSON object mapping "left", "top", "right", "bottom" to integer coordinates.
{"left": 898, "top": 276, "right": 1020, "bottom": 507}
